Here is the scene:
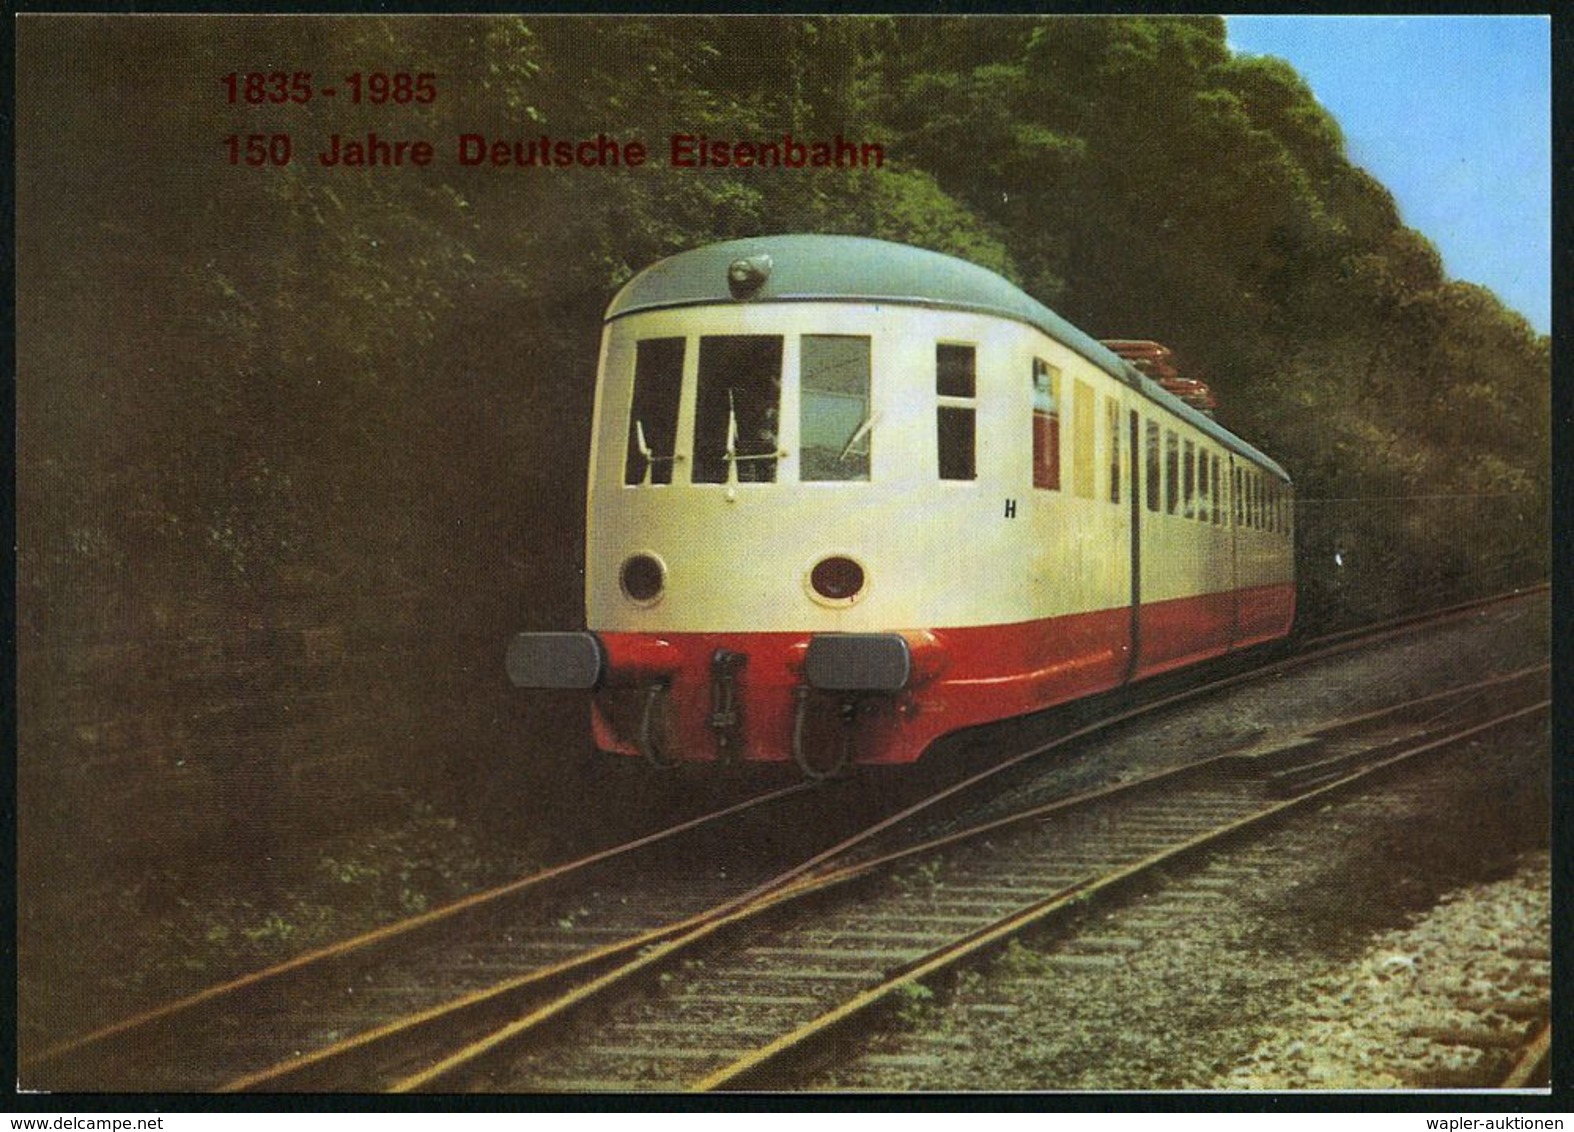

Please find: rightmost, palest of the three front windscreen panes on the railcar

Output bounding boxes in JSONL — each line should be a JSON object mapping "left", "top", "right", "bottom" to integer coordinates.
{"left": 798, "top": 334, "right": 874, "bottom": 482}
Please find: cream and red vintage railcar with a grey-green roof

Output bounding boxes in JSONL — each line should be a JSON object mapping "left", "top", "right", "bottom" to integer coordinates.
{"left": 507, "top": 235, "right": 1295, "bottom": 775}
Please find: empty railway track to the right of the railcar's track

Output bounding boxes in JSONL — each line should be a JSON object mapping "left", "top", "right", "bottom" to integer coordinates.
{"left": 382, "top": 669, "right": 1546, "bottom": 1091}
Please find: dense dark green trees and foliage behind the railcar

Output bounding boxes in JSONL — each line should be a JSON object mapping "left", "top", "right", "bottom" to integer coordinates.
{"left": 16, "top": 17, "right": 1549, "bottom": 1039}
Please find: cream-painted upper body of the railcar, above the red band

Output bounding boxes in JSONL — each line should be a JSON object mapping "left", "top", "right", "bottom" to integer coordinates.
{"left": 586, "top": 301, "right": 1284, "bottom": 633}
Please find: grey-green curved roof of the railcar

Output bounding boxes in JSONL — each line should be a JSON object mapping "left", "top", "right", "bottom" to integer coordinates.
{"left": 606, "top": 235, "right": 1289, "bottom": 480}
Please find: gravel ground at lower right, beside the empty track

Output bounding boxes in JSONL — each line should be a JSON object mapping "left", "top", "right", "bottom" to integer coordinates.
{"left": 818, "top": 739, "right": 1552, "bottom": 1094}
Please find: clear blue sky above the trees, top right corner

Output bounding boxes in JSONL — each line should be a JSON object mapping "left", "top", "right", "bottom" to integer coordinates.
{"left": 1228, "top": 16, "right": 1552, "bottom": 332}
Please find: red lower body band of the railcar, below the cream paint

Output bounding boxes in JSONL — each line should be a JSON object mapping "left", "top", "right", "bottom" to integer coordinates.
{"left": 592, "top": 584, "right": 1295, "bottom": 764}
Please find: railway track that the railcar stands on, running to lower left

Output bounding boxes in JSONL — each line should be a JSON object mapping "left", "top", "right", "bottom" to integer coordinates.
{"left": 22, "top": 588, "right": 1548, "bottom": 1089}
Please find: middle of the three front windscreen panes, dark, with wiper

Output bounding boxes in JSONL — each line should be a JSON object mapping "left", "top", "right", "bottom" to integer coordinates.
{"left": 694, "top": 334, "right": 782, "bottom": 483}
